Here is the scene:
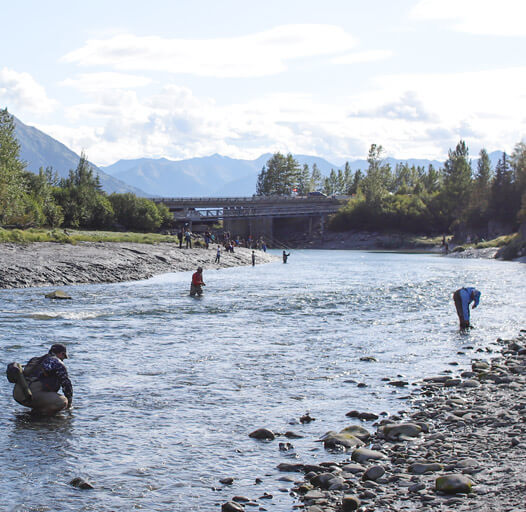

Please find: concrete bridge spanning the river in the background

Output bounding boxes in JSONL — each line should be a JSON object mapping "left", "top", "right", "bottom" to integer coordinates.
{"left": 153, "top": 194, "right": 349, "bottom": 239}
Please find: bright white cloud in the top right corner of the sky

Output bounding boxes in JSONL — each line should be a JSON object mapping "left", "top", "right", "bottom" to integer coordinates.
{"left": 410, "top": 0, "right": 526, "bottom": 37}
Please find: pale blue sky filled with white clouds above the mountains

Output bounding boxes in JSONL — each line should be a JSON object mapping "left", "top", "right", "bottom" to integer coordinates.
{"left": 0, "top": 0, "right": 526, "bottom": 166}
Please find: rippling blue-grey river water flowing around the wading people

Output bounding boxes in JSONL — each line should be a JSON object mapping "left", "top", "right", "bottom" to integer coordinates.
{"left": 0, "top": 250, "right": 526, "bottom": 512}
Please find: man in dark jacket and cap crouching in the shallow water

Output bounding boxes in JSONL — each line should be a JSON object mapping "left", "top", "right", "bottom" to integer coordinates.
{"left": 13, "top": 343, "right": 73, "bottom": 415}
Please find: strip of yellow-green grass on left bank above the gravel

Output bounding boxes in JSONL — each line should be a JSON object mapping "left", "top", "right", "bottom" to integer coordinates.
{"left": 0, "top": 228, "right": 178, "bottom": 244}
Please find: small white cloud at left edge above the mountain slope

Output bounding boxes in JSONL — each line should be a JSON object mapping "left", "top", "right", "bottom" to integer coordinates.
{"left": 0, "top": 67, "right": 57, "bottom": 113}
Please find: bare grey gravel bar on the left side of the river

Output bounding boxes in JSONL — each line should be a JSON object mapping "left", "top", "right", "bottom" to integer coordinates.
{"left": 0, "top": 242, "right": 278, "bottom": 288}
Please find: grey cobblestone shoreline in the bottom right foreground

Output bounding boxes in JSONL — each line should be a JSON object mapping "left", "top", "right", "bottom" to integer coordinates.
{"left": 222, "top": 330, "right": 526, "bottom": 512}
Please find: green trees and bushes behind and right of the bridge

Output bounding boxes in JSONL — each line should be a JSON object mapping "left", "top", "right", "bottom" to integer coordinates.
{"left": 256, "top": 140, "right": 526, "bottom": 237}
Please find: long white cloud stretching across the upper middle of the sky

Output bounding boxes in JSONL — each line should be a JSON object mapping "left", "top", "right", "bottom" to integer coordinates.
{"left": 63, "top": 25, "right": 355, "bottom": 77}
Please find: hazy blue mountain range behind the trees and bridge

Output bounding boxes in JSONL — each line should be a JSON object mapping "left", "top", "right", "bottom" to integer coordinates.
{"left": 14, "top": 117, "right": 508, "bottom": 197}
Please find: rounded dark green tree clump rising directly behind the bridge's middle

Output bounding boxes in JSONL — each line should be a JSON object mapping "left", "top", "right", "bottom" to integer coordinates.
{"left": 256, "top": 153, "right": 301, "bottom": 196}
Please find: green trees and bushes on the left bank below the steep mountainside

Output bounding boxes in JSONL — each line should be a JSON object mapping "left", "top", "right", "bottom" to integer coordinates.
{"left": 0, "top": 109, "right": 171, "bottom": 232}
